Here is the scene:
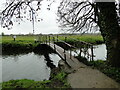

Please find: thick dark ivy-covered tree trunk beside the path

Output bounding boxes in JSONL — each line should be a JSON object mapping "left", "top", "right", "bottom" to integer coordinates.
{"left": 97, "top": 2, "right": 120, "bottom": 67}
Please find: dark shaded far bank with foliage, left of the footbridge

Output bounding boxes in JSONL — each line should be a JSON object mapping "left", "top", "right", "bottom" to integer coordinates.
{"left": 2, "top": 41, "right": 35, "bottom": 54}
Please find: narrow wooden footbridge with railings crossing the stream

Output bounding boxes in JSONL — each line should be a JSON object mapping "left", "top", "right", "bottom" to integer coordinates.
{"left": 38, "top": 35, "right": 94, "bottom": 68}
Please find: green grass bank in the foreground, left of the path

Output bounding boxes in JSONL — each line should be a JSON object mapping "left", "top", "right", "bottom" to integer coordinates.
{"left": 2, "top": 68, "right": 70, "bottom": 89}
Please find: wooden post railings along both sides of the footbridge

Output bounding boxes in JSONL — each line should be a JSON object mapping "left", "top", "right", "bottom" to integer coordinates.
{"left": 39, "top": 35, "right": 94, "bottom": 61}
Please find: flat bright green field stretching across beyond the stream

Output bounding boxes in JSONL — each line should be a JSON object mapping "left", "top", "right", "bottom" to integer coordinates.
{"left": 2, "top": 35, "right": 103, "bottom": 44}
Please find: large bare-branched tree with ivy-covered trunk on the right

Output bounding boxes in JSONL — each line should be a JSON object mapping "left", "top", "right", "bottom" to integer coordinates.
{"left": 58, "top": 0, "right": 120, "bottom": 67}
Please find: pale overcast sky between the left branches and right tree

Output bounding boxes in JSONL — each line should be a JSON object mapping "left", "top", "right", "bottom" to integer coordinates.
{"left": 0, "top": 0, "right": 61, "bottom": 34}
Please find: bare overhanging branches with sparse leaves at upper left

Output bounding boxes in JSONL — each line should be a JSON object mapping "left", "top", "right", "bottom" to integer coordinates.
{"left": 0, "top": 0, "right": 54, "bottom": 33}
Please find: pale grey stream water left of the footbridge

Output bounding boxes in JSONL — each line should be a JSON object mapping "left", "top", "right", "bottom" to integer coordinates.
{"left": 0, "top": 52, "right": 60, "bottom": 81}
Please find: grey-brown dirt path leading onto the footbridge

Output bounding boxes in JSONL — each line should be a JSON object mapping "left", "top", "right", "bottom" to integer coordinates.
{"left": 60, "top": 62, "right": 120, "bottom": 89}
